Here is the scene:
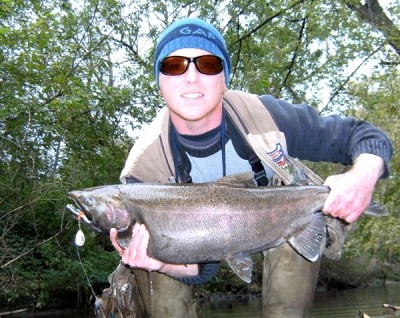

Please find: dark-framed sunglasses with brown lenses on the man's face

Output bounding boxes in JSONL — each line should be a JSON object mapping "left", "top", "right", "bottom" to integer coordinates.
{"left": 160, "top": 55, "right": 224, "bottom": 76}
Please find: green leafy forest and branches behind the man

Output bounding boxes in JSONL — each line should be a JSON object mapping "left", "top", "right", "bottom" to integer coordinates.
{"left": 0, "top": 0, "right": 400, "bottom": 314}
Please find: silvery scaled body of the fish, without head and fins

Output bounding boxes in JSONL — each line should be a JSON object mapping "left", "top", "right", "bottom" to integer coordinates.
{"left": 114, "top": 185, "right": 327, "bottom": 264}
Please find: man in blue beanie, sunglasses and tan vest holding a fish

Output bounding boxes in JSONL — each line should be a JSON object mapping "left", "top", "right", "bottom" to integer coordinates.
{"left": 110, "top": 18, "right": 392, "bottom": 318}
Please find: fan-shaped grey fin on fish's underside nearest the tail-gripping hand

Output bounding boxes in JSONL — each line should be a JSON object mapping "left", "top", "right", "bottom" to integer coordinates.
{"left": 288, "top": 212, "right": 326, "bottom": 262}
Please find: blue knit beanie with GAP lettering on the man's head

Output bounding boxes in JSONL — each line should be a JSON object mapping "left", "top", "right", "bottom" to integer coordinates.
{"left": 154, "top": 18, "right": 231, "bottom": 86}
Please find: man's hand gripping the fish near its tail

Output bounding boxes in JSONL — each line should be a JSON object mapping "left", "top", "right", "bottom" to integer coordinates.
{"left": 323, "top": 154, "right": 384, "bottom": 222}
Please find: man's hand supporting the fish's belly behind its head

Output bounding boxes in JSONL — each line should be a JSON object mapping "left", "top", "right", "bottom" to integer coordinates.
{"left": 110, "top": 224, "right": 198, "bottom": 277}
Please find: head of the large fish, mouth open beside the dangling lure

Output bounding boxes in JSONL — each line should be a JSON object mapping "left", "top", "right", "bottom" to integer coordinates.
{"left": 68, "top": 186, "right": 134, "bottom": 232}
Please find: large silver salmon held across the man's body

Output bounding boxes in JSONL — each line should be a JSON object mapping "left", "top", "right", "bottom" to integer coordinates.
{"left": 67, "top": 177, "right": 329, "bottom": 282}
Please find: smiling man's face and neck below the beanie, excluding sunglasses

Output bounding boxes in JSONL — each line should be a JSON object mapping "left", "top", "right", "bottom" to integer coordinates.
{"left": 159, "top": 49, "right": 226, "bottom": 135}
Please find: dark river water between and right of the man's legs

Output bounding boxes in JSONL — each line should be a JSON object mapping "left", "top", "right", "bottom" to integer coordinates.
{"left": 201, "top": 284, "right": 400, "bottom": 318}
